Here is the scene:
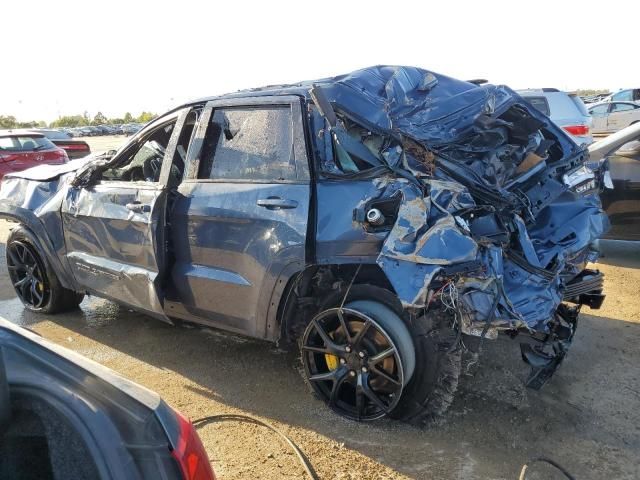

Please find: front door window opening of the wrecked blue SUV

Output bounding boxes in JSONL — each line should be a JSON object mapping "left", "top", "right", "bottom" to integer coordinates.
{"left": 102, "top": 119, "right": 176, "bottom": 182}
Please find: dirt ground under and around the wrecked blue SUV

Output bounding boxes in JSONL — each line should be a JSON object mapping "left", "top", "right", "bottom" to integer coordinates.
{"left": 0, "top": 142, "right": 640, "bottom": 480}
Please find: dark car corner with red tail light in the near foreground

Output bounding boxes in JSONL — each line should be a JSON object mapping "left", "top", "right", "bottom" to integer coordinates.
{"left": 0, "top": 317, "right": 215, "bottom": 480}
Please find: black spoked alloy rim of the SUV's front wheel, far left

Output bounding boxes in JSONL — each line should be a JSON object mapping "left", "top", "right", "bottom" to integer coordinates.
{"left": 7, "top": 241, "right": 51, "bottom": 310}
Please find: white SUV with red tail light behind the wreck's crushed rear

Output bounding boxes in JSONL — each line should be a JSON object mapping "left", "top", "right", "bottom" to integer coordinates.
{"left": 516, "top": 88, "right": 593, "bottom": 145}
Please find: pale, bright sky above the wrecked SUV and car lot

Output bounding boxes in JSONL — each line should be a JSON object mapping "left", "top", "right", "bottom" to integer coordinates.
{"left": 0, "top": 0, "right": 640, "bottom": 121}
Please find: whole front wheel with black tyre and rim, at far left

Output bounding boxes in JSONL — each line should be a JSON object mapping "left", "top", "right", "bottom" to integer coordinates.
{"left": 6, "top": 226, "right": 84, "bottom": 313}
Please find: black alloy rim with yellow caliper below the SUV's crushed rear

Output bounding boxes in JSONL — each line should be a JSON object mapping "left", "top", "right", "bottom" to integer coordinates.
{"left": 301, "top": 307, "right": 407, "bottom": 420}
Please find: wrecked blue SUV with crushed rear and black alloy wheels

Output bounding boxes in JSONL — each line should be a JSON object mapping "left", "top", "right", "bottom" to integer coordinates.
{"left": 0, "top": 66, "right": 607, "bottom": 423}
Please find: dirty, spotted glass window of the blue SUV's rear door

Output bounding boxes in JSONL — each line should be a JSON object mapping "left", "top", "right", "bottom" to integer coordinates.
{"left": 198, "top": 106, "right": 296, "bottom": 181}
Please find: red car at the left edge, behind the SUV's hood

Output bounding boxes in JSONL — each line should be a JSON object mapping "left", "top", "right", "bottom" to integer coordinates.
{"left": 0, "top": 131, "right": 69, "bottom": 178}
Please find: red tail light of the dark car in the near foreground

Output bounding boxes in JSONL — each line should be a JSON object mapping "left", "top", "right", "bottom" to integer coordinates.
{"left": 171, "top": 412, "right": 216, "bottom": 480}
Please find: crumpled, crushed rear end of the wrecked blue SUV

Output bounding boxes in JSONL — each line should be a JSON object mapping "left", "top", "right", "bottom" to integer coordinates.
{"left": 310, "top": 67, "right": 608, "bottom": 388}
